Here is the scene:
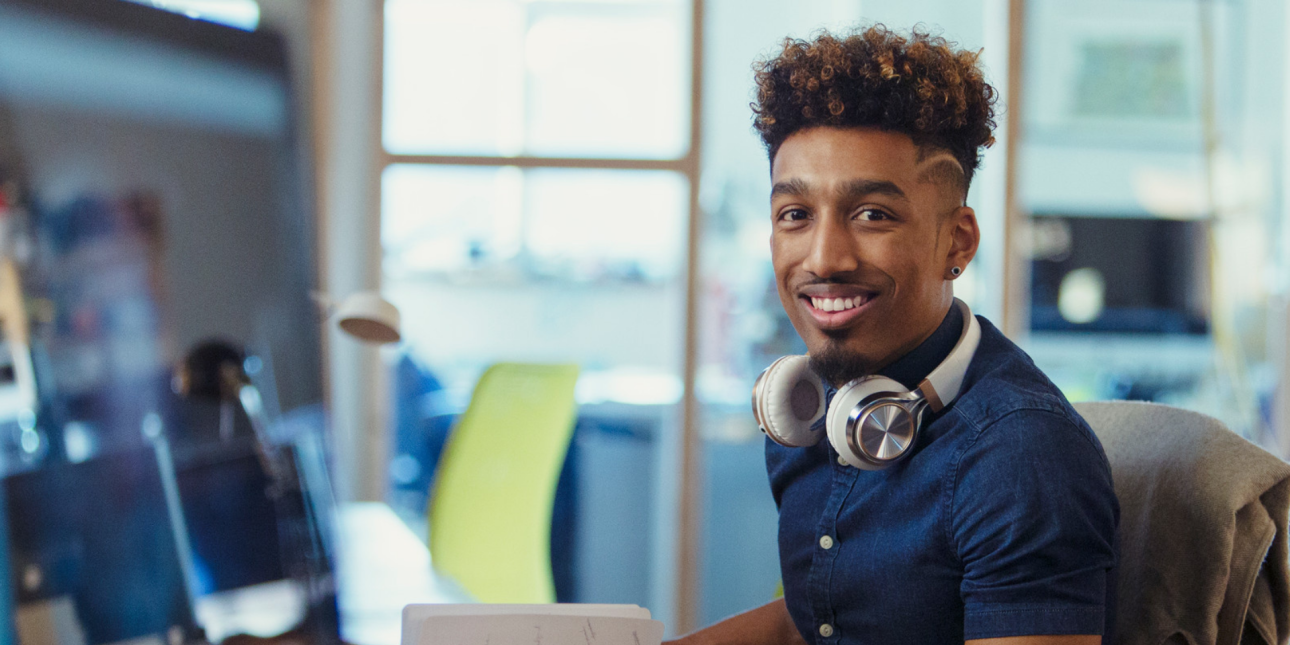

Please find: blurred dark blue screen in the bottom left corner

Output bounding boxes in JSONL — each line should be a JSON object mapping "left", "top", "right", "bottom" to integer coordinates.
{"left": 4, "top": 448, "right": 197, "bottom": 645}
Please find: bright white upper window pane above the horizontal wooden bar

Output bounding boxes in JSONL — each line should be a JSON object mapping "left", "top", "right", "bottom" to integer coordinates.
{"left": 384, "top": 0, "right": 690, "bottom": 159}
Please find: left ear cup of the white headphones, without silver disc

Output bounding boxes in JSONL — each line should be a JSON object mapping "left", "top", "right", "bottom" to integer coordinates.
{"left": 753, "top": 356, "right": 826, "bottom": 446}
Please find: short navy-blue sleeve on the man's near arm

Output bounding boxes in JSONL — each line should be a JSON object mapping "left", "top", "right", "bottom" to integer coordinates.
{"left": 949, "top": 410, "right": 1118, "bottom": 640}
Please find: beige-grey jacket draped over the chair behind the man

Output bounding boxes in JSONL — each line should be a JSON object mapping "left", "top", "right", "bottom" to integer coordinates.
{"left": 1075, "top": 401, "right": 1290, "bottom": 645}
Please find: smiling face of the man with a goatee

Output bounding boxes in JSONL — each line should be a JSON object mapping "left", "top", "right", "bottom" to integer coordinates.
{"left": 770, "top": 128, "right": 979, "bottom": 384}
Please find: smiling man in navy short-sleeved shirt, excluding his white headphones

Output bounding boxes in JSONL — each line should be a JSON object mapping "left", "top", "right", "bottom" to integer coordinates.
{"left": 682, "top": 26, "right": 1118, "bottom": 645}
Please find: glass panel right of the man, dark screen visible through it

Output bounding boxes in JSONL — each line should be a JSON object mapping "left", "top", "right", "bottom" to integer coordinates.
{"left": 1018, "top": 0, "right": 1290, "bottom": 441}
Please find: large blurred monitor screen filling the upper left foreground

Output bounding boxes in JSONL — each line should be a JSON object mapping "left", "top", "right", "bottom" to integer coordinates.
{"left": 0, "top": 0, "right": 321, "bottom": 462}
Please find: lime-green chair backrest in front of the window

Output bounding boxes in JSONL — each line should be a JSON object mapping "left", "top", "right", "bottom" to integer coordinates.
{"left": 430, "top": 364, "right": 578, "bottom": 602}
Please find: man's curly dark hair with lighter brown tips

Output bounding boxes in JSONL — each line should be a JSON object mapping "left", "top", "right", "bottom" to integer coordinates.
{"left": 752, "top": 25, "right": 997, "bottom": 192}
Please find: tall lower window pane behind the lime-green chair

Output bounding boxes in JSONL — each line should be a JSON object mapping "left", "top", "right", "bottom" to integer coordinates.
{"left": 382, "top": 165, "right": 689, "bottom": 618}
